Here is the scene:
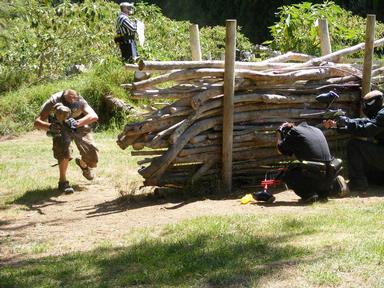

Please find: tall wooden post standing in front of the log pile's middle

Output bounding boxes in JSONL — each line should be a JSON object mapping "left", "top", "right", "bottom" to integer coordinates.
{"left": 222, "top": 20, "right": 237, "bottom": 194}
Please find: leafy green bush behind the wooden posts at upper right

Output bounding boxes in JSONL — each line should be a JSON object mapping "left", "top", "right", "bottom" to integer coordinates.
{"left": 266, "top": 1, "right": 384, "bottom": 55}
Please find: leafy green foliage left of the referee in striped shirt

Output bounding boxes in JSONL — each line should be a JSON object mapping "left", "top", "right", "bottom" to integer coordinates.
{"left": 0, "top": 0, "right": 114, "bottom": 91}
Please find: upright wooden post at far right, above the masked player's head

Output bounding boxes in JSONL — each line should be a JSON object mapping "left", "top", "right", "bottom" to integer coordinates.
{"left": 361, "top": 14, "right": 376, "bottom": 97}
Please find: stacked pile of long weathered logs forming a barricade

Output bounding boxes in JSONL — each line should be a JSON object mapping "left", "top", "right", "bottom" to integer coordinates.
{"left": 117, "top": 42, "right": 380, "bottom": 187}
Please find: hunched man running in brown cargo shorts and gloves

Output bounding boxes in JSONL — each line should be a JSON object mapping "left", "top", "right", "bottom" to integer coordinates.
{"left": 34, "top": 89, "right": 98, "bottom": 194}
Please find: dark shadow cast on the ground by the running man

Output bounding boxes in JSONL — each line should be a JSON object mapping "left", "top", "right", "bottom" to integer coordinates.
{"left": 10, "top": 186, "right": 81, "bottom": 214}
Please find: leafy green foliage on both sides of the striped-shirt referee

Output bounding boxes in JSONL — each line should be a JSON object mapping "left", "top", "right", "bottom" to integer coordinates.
{"left": 0, "top": 0, "right": 255, "bottom": 93}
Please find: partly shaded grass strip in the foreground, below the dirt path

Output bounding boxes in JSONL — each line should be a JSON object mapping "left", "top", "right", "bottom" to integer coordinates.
{"left": 0, "top": 203, "right": 384, "bottom": 287}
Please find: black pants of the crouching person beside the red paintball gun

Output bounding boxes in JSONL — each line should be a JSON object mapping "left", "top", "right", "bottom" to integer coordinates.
{"left": 282, "top": 165, "right": 337, "bottom": 199}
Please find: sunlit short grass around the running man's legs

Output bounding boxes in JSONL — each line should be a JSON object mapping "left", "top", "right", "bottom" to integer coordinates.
{"left": 0, "top": 131, "right": 140, "bottom": 209}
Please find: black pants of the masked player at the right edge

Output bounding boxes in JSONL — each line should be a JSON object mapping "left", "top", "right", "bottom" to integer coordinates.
{"left": 347, "top": 139, "right": 384, "bottom": 187}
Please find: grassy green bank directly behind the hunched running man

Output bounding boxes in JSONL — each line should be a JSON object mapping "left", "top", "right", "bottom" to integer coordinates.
{"left": 0, "top": 57, "right": 133, "bottom": 135}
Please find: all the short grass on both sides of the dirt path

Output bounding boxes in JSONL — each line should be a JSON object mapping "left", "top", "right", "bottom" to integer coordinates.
{"left": 0, "top": 131, "right": 384, "bottom": 288}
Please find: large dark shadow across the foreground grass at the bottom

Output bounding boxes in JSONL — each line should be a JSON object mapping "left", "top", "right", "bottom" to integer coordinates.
{"left": 0, "top": 230, "right": 319, "bottom": 288}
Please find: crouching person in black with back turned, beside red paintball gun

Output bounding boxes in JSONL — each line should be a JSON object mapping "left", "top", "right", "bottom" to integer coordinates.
{"left": 256, "top": 122, "right": 346, "bottom": 203}
